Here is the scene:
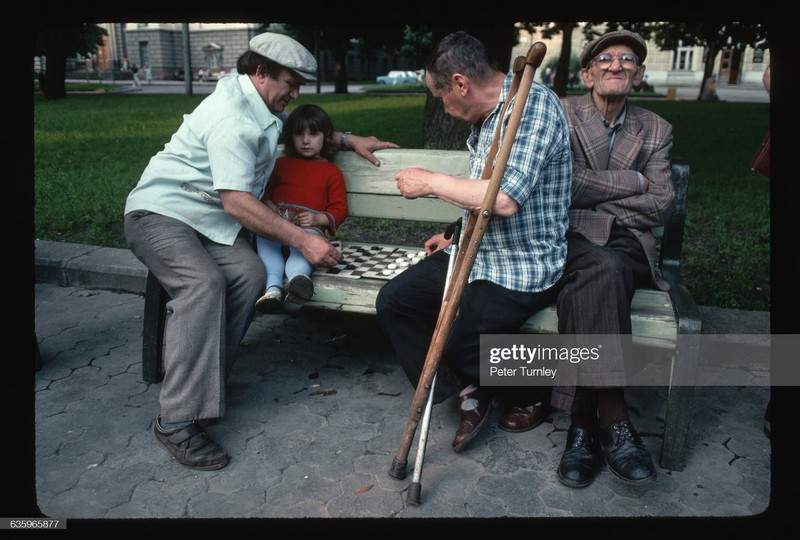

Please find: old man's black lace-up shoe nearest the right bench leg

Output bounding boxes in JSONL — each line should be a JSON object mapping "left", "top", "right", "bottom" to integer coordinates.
{"left": 600, "top": 421, "right": 656, "bottom": 484}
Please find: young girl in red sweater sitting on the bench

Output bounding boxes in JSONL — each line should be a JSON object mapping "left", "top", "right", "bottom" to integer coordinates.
{"left": 256, "top": 104, "right": 347, "bottom": 313}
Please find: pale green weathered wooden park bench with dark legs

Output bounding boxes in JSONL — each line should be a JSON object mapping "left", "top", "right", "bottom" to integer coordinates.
{"left": 142, "top": 149, "right": 701, "bottom": 470}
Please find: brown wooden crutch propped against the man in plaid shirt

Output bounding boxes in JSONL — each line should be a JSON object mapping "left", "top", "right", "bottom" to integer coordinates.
{"left": 389, "top": 42, "right": 547, "bottom": 486}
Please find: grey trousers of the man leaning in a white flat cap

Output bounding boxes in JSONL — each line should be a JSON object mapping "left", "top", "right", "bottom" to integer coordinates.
{"left": 125, "top": 211, "right": 266, "bottom": 422}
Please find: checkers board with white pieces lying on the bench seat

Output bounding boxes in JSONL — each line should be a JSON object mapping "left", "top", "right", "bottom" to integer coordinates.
{"left": 314, "top": 244, "right": 425, "bottom": 280}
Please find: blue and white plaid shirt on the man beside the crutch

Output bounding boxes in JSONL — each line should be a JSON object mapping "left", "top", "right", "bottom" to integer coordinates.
{"left": 464, "top": 72, "right": 572, "bottom": 292}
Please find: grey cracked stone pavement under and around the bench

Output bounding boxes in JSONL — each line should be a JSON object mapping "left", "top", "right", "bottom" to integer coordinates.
{"left": 28, "top": 283, "right": 772, "bottom": 525}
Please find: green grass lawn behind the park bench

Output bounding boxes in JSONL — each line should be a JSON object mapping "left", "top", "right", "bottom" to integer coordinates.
{"left": 34, "top": 92, "right": 770, "bottom": 310}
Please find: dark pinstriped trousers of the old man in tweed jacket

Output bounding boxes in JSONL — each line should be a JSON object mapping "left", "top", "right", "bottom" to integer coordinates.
{"left": 552, "top": 226, "right": 650, "bottom": 412}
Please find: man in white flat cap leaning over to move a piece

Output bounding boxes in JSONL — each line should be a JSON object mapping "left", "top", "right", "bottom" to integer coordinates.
{"left": 125, "top": 33, "right": 397, "bottom": 470}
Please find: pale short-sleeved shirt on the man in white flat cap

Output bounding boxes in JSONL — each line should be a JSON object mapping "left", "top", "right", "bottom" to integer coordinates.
{"left": 125, "top": 75, "right": 285, "bottom": 245}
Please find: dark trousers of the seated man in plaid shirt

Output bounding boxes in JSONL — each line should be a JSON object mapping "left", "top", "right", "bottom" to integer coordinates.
{"left": 376, "top": 251, "right": 555, "bottom": 406}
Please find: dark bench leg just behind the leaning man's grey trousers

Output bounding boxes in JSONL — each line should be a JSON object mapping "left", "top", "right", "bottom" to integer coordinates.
{"left": 142, "top": 272, "right": 169, "bottom": 383}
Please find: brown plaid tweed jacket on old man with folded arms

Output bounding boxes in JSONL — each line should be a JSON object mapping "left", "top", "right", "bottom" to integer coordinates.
{"left": 562, "top": 93, "right": 674, "bottom": 290}
